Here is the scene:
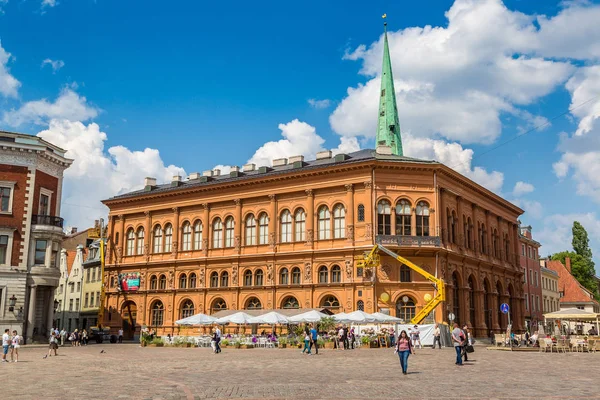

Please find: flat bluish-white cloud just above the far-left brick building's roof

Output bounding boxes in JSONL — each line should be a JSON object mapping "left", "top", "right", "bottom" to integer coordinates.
{"left": 3, "top": 88, "right": 100, "bottom": 127}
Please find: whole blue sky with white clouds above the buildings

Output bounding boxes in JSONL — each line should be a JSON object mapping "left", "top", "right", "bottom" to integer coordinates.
{"left": 0, "top": 0, "right": 600, "bottom": 266}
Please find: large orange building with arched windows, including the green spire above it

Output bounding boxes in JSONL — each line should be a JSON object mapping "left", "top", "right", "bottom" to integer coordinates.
{"left": 102, "top": 24, "right": 524, "bottom": 337}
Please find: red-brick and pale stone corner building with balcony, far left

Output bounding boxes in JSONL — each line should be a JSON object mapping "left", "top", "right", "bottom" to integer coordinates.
{"left": 0, "top": 131, "right": 72, "bottom": 342}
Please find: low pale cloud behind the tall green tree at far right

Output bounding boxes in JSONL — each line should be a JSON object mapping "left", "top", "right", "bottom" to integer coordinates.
{"left": 533, "top": 213, "right": 600, "bottom": 265}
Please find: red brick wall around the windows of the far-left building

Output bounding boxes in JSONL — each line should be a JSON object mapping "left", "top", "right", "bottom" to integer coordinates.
{"left": 0, "top": 164, "right": 27, "bottom": 265}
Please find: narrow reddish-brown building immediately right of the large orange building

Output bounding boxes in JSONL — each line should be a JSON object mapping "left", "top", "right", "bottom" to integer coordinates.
{"left": 519, "top": 226, "right": 544, "bottom": 333}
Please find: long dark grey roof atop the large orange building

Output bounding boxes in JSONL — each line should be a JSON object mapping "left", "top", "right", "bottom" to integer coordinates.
{"left": 109, "top": 149, "right": 439, "bottom": 200}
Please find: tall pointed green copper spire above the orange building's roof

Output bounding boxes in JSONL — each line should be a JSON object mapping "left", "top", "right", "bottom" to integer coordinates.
{"left": 376, "top": 18, "right": 404, "bottom": 156}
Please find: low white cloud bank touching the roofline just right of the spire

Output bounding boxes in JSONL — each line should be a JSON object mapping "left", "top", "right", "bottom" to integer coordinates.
{"left": 402, "top": 134, "right": 504, "bottom": 193}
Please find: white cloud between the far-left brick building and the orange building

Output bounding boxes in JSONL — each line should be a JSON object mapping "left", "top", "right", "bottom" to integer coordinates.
{"left": 38, "top": 119, "right": 186, "bottom": 228}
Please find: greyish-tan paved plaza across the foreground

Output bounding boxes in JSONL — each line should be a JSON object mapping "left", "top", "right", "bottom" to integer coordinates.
{"left": 0, "top": 344, "right": 600, "bottom": 400}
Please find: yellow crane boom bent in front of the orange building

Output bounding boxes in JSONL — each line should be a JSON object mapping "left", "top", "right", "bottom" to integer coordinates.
{"left": 357, "top": 245, "right": 446, "bottom": 324}
